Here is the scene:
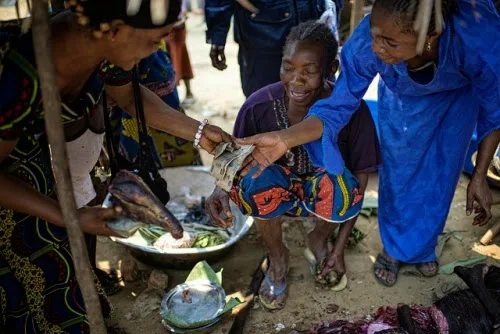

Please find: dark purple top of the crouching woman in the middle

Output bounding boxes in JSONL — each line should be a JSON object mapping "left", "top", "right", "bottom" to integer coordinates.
{"left": 233, "top": 82, "right": 382, "bottom": 175}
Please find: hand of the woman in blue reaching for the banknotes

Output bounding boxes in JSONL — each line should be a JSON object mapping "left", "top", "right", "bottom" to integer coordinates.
{"left": 235, "top": 131, "right": 290, "bottom": 178}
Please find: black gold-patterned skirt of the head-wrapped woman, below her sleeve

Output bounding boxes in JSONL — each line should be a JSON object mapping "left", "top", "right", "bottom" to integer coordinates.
{"left": 0, "top": 137, "right": 112, "bottom": 334}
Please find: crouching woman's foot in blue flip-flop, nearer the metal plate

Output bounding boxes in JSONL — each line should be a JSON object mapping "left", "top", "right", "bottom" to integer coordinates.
{"left": 259, "top": 256, "right": 288, "bottom": 310}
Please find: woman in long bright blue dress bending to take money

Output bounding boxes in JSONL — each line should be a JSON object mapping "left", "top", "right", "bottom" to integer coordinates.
{"left": 238, "top": 0, "right": 500, "bottom": 286}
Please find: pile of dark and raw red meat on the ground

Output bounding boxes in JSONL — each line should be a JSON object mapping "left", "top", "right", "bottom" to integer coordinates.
{"left": 303, "top": 264, "right": 500, "bottom": 334}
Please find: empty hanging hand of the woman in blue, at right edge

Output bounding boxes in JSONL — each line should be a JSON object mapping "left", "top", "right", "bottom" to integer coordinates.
{"left": 466, "top": 172, "right": 493, "bottom": 226}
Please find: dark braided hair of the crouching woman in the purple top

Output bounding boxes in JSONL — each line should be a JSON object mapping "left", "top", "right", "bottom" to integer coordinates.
{"left": 283, "top": 20, "right": 339, "bottom": 71}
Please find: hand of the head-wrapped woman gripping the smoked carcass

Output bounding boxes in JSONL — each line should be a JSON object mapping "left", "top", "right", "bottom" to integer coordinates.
{"left": 78, "top": 206, "right": 122, "bottom": 237}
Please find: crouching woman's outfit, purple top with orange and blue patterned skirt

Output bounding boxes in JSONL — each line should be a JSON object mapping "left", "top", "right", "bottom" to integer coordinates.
{"left": 229, "top": 82, "right": 380, "bottom": 223}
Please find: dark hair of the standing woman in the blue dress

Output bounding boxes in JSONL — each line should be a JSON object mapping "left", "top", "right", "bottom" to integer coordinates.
{"left": 372, "top": 0, "right": 458, "bottom": 33}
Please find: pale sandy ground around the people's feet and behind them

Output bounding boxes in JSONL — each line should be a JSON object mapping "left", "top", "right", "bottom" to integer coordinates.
{"left": 0, "top": 3, "right": 500, "bottom": 334}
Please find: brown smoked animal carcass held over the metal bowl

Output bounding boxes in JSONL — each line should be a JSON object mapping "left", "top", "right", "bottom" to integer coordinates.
{"left": 108, "top": 170, "right": 183, "bottom": 239}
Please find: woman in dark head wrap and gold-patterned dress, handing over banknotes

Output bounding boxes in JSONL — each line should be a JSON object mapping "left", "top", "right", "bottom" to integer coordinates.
{"left": 0, "top": 0, "right": 230, "bottom": 333}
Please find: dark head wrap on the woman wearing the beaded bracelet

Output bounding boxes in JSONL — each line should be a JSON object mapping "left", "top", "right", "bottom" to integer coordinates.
{"left": 65, "top": 0, "right": 182, "bottom": 37}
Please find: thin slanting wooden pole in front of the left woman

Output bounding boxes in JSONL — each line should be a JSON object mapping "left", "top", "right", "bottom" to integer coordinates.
{"left": 32, "top": 0, "right": 106, "bottom": 334}
